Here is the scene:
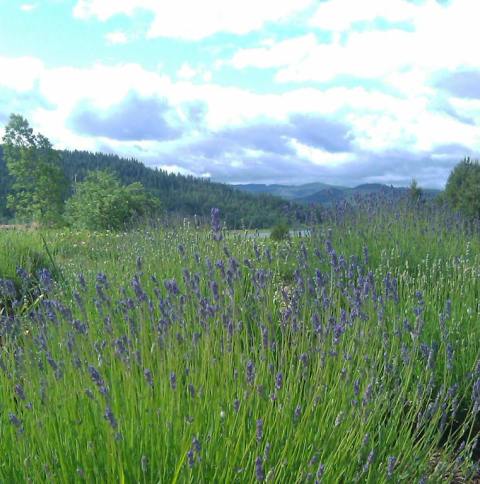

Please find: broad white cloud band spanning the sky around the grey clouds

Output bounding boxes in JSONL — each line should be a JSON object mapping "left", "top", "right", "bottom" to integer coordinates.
{"left": 0, "top": 46, "right": 480, "bottom": 185}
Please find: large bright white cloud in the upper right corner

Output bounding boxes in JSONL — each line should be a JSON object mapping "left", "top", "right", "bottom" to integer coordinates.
{"left": 230, "top": 0, "right": 480, "bottom": 88}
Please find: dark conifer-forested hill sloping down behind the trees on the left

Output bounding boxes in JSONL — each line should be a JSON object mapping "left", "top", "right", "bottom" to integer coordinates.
{"left": 0, "top": 147, "right": 302, "bottom": 228}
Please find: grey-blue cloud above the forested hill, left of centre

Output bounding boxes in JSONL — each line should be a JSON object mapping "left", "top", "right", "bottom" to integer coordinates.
{"left": 69, "top": 94, "right": 182, "bottom": 141}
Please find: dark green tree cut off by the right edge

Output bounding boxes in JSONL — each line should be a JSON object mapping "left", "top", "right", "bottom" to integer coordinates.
{"left": 444, "top": 158, "right": 480, "bottom": 218}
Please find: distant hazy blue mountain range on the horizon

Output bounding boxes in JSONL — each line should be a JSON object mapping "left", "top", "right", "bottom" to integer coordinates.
{"left": 234, "top": 182, "right": 440, "bottom": 205}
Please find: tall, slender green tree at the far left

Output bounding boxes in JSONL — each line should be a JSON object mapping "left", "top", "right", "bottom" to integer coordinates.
{"left": 3, "top": 114, "right": 66, "bottom": 224}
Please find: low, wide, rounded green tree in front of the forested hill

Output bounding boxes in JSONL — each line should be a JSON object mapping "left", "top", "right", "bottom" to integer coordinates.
{"left": 65, "top": 170, "right": 161, "bottom": 230}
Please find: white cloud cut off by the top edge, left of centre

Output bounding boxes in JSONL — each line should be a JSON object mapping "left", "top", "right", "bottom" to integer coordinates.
{"left": 73, "top": 0, "right": 314, "bottom": 40}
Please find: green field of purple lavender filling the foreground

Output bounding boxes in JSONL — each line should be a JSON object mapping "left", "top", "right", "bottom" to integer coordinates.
{"left": 0, "top": 201, "right": 480, "bottom": 483}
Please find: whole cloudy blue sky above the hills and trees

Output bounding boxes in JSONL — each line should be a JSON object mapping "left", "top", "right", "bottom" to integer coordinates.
{"left": 0, "top": 0, "right": 480, "bottom": 188}
